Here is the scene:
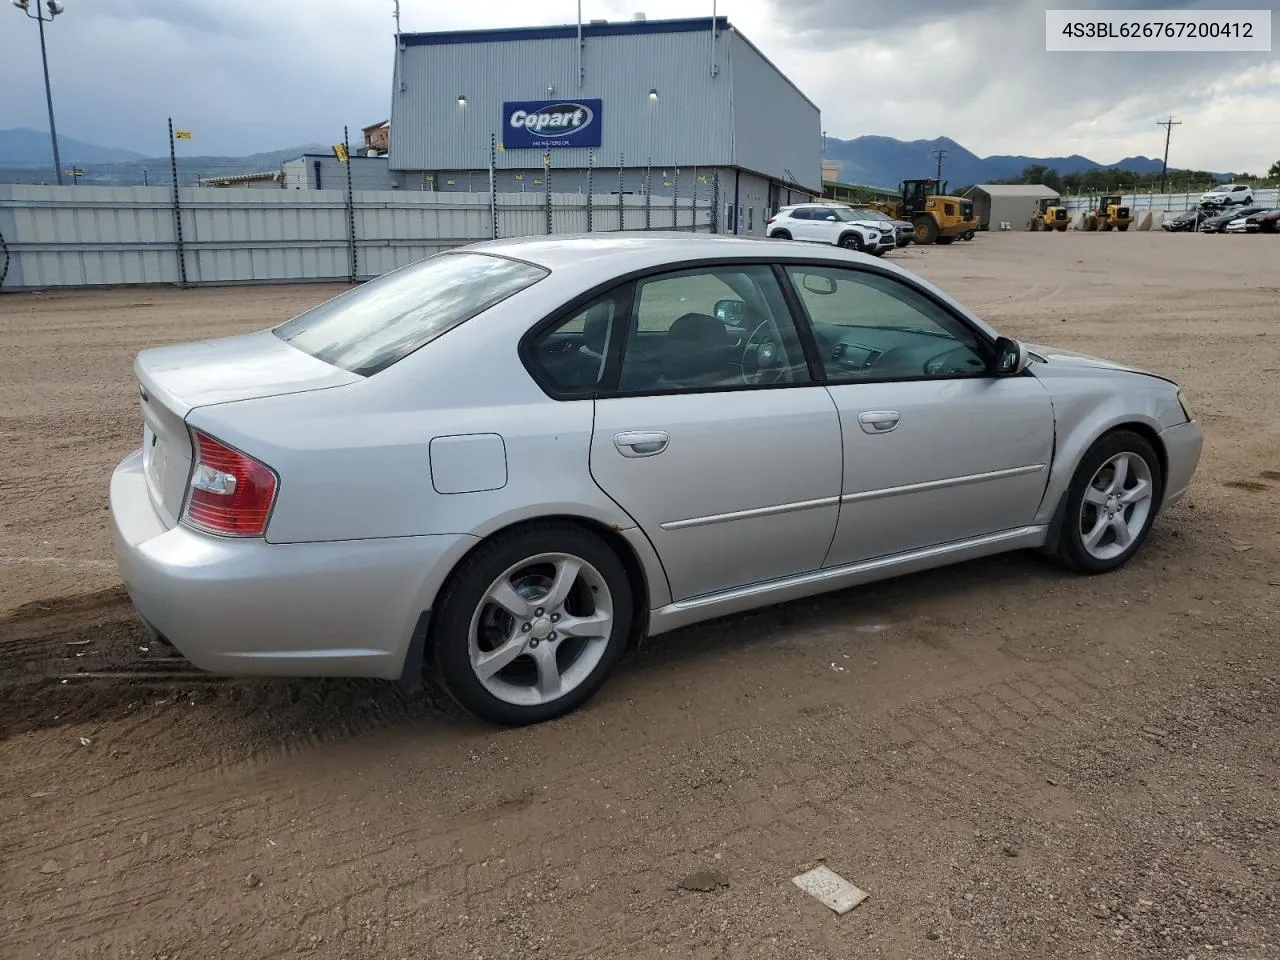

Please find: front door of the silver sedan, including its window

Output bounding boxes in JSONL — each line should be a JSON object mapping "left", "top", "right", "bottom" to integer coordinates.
{"left": 785, "top": 266, "right": 1053, "bottom": 566}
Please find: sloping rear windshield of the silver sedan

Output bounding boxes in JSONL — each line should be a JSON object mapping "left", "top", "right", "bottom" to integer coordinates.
{"left": 274, "top": 253, "right": 548, "bottom": 376}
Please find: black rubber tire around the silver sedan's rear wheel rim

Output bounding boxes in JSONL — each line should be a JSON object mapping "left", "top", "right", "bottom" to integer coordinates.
{"left": 428, "top": 521, "right": 635, "bottom": 726}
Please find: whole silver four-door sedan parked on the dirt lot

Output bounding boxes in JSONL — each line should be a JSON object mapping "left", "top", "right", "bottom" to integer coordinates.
{"left": 110, "top": 233, "right": 1202, "bottom": 724}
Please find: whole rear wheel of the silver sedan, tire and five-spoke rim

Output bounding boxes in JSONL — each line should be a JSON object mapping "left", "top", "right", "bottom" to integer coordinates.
{"left": 429, "top": 522, "right": 634, "bottom": 726}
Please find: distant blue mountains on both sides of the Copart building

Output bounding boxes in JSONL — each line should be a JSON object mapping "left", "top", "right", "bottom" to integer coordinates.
{"left": 0, "top": 128, "right": 1230, "bottom": 191}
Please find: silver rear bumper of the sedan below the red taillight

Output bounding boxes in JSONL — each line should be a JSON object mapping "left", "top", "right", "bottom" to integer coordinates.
{"left": 110, "top": 451, "right": 475, "bottom": 680}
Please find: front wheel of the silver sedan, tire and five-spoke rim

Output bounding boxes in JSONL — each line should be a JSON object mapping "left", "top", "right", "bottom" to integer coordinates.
{"left": 1056, "top": 430, "right": 1164, "bottom": 573}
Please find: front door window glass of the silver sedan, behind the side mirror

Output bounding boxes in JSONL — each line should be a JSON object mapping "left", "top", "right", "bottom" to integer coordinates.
{"left": 786, "top": 266, "right": 988, "bottom": 383}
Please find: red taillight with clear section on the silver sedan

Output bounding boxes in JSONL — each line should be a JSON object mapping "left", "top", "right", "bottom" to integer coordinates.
{"left": 182, "top": 430, "right": 279, "bottom": 536}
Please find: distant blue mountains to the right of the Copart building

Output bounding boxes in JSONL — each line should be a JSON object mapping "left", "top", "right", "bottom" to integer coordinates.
{"left": 824, "top": 137, "right": 1230, "bottom": 191}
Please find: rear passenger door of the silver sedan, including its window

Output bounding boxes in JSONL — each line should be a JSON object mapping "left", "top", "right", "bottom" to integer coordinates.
{"left": 590, "top": 264, "right": 842, "bottom": 600}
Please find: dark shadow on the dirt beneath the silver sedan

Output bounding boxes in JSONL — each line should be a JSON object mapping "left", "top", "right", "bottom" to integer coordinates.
{"left": 0, "top": 527, "right": 1185, "bottom": 749}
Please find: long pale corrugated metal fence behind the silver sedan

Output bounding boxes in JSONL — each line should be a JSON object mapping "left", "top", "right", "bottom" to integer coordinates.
{"left": 0, "top": 184, "right": 719, "bottom": 291}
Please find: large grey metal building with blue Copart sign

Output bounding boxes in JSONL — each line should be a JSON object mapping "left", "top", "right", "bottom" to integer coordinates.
{"left": 389, "top": 14, "right": 822, "bottom": 234}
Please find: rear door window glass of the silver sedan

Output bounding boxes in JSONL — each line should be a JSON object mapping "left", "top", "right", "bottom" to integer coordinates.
{"left": 618, "top": 265, "right": 809, "bottom": 393}
